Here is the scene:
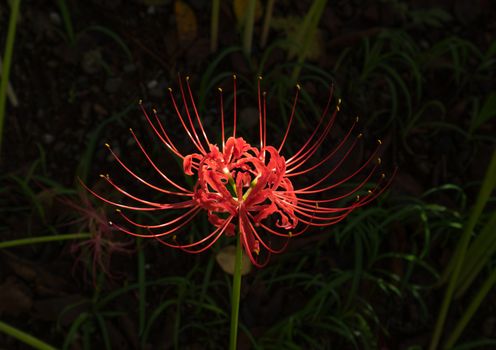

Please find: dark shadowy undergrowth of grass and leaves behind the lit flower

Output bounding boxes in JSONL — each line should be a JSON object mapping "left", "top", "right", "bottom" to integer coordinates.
{"left": 0, "top": 0, "right": 496, "bottom": 350}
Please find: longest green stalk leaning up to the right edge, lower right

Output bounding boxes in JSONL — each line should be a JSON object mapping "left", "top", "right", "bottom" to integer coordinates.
{"left": 429, "top": 151, "right": 496, "bottom": 350}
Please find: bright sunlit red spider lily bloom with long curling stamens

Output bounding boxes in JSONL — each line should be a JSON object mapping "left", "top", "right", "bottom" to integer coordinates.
{"left": 84, "top": 76, "right": 396, "bottom": 267}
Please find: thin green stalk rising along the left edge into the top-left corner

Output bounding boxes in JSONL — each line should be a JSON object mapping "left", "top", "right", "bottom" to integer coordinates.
{"left": 0, "top": 0, "right": 21, "bottom": 156}
